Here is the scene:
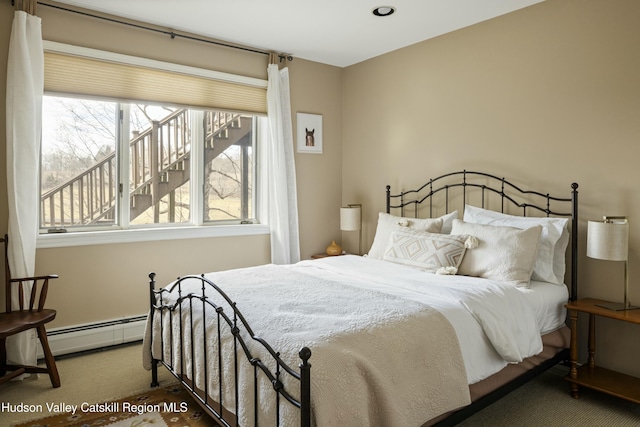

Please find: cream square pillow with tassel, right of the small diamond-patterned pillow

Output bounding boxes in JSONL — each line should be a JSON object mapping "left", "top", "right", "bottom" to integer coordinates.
{"left": 451, "top": 219, "right": 542, "bottom": 287}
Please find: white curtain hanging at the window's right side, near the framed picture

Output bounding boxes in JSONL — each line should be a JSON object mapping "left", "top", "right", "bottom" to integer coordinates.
{"left": 258, "top": 64, "right": 300, "bottom": 264}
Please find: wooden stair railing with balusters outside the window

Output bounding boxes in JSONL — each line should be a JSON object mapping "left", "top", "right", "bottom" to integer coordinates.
{"left": 40, "top": 109, "right": 240, "bottom": 228}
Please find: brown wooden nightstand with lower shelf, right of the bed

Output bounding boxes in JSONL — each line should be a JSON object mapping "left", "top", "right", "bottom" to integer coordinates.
{"left": 565, "top": 298, "right": 640, "bottom": 403}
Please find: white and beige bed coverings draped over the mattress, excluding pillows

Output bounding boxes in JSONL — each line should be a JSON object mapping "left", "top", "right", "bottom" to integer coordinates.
{"left": 145, "top": 256, "right": 542, "bottom": 426}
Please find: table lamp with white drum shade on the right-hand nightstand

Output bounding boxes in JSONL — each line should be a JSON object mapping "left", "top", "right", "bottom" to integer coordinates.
{"left": 587, "top": 216, "right": 638, "bottom": 311}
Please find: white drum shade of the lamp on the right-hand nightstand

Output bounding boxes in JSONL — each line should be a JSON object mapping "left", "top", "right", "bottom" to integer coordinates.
{"left": 587, "top": 219, "right": 629, "bottom": 261}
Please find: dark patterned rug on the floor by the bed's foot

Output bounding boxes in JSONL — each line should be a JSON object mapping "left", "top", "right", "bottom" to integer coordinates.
{"left": 12, "top": 384, "right": 217, "bottom": 427}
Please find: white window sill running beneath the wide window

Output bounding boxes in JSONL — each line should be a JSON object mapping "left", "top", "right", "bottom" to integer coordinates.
{"left": 36, "top": 224, "right": 269, "bottom": 249}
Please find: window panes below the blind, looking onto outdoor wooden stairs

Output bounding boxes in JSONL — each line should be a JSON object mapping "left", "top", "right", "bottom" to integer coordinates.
{"left": 40, "top": 96, "right": 256, "bottom": 232}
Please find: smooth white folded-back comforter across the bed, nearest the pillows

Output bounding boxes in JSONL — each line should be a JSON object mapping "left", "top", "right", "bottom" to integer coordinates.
{"left": 298, "top": 256, "right": 544, "bottom": 384}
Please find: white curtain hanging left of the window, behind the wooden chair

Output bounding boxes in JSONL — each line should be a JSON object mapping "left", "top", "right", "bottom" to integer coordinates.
{"left": 7, "top": 11, "right": 44, "bottom": 365}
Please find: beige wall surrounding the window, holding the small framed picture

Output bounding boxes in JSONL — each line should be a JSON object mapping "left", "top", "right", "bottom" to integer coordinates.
{"left": 0, "top": 2, "right": 342, "bottom": 327}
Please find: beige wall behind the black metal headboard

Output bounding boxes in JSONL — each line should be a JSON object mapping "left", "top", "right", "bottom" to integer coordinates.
{"left": 342, "top": 0, "right": 640, "bottom": 375}
